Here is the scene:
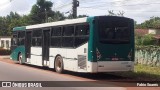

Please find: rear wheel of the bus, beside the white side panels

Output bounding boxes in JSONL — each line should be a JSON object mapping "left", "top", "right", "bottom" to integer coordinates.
{"left": 54, "top": 56, "right": 64, "bottom": 73}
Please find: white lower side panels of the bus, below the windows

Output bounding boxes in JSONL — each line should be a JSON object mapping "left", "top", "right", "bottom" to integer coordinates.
{"left": 26, "top": 43, "right": 89, "bottom": 72}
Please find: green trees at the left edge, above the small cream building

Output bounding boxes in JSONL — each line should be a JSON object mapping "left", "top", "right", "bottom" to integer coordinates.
{"left": 0, "top": 12, "right": 31, "bottom": 36}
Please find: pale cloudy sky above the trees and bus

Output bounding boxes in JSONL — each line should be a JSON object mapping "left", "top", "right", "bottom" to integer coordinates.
{"left": 0, "top": 0, "right": 160, "bottom": 23}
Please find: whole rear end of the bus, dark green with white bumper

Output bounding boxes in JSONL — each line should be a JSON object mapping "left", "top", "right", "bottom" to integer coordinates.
{"left": 88, "top": 16, "right": 134, "bottom": 72}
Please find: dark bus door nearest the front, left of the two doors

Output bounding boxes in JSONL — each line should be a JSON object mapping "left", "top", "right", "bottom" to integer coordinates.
{"left": 25, "top": 31, "right": 32, "bottom": 61}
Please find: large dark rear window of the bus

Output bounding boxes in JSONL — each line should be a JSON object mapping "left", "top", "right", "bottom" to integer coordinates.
{"left": 98, "top": 19, "right": 131, "bottom": 44}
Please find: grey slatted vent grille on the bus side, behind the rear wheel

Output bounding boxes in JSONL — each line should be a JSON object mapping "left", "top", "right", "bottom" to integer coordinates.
{"left": 78, "top": 55, "right": 86, "bottom": 69}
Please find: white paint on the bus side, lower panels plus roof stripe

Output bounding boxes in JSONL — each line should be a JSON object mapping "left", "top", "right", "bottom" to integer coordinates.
{"left": 26, "top": 17, "right": 91, "bottom": 72}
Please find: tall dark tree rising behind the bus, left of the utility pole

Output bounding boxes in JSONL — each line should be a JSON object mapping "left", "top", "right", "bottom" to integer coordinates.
{"left": 30, "top": 0, "right": 54, "bottom": 24}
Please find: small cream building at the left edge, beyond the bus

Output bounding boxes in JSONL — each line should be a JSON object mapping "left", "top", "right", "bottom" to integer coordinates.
{"left": 0, "top": 36, "right": 11, "bottom": 49}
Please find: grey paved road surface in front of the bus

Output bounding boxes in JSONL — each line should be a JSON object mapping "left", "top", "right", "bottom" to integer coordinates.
{"left": 0, "top": 61, "right": 126, "bottom": 90}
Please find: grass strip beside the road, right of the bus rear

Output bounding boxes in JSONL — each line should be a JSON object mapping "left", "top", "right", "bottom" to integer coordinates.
{"left": 115, "top": 65, "right": 160, "bottom": 81}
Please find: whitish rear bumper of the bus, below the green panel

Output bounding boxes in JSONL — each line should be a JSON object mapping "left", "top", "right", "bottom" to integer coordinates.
{"left": 87, "top": 61, "right": 134, "bottom": 73}
